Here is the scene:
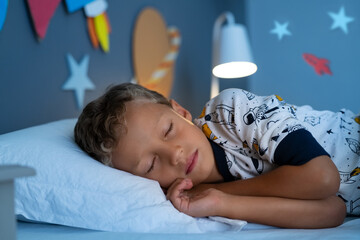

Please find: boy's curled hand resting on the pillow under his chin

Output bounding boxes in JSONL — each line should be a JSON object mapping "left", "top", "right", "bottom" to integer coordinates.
{"left": 167, "top": 179, "right": 225, "bottom": 217}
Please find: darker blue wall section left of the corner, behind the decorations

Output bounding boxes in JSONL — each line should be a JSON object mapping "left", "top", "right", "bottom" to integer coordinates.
{"left": 0, "top": 0, "right": 245, "bottom": 134}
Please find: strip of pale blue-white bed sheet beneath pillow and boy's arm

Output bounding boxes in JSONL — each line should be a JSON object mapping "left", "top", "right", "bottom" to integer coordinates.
{"left": 17, "top": 218, "right": 360, "bottom": 240}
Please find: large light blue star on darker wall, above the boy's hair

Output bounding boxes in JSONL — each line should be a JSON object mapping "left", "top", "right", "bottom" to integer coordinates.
{"left": 62, "top": 54, "right": 95, "bottom": 109}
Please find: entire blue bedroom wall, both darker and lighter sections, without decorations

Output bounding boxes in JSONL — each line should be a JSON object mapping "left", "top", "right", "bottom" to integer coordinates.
{"left": 0, "top": 0, "right": 360, "bottom": 134}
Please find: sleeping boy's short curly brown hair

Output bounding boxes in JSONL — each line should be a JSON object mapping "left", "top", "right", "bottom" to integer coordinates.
{"left": 74, "top": 83, "right": 171, "bottom": 166}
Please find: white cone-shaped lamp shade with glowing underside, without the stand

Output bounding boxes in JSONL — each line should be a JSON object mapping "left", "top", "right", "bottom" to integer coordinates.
{"left": 213, "top": 24, "right": 257, "bottom": 78}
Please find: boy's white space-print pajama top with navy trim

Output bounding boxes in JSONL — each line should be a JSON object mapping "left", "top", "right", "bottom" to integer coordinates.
{"left": 194, "top": 89, "right": 360, "bottom": 215}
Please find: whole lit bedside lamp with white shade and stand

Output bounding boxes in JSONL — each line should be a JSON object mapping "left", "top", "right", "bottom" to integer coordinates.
{"left": 210, "top": 12, "right": 257, "bottom": 98}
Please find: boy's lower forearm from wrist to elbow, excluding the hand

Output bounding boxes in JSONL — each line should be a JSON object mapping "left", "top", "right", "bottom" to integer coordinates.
{"left": 219, "top": 190, "right": 346, "bottom": 228}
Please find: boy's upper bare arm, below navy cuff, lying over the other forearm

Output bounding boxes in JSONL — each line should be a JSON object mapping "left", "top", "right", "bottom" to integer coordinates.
{"left": 197, "top": 156, "right": 340, "bottom": 199}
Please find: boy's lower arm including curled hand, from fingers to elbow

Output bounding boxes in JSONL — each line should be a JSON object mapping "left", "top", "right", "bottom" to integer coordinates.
{"left": 167, "top": 179, "right": 346, "bottom": 228}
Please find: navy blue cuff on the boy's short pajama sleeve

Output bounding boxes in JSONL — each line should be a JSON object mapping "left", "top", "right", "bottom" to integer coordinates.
{"left": 274, "top": 129, "right": 329, "bottom": 166}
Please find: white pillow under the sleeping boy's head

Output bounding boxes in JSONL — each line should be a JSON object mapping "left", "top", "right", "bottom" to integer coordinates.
{"left": 0, "top": 119, "right": 232, "bottom": 233}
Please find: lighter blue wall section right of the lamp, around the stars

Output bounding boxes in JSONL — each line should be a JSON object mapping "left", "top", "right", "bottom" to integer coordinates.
{"left": 246, "top": 0, "right": 360, "bottom": 113}
